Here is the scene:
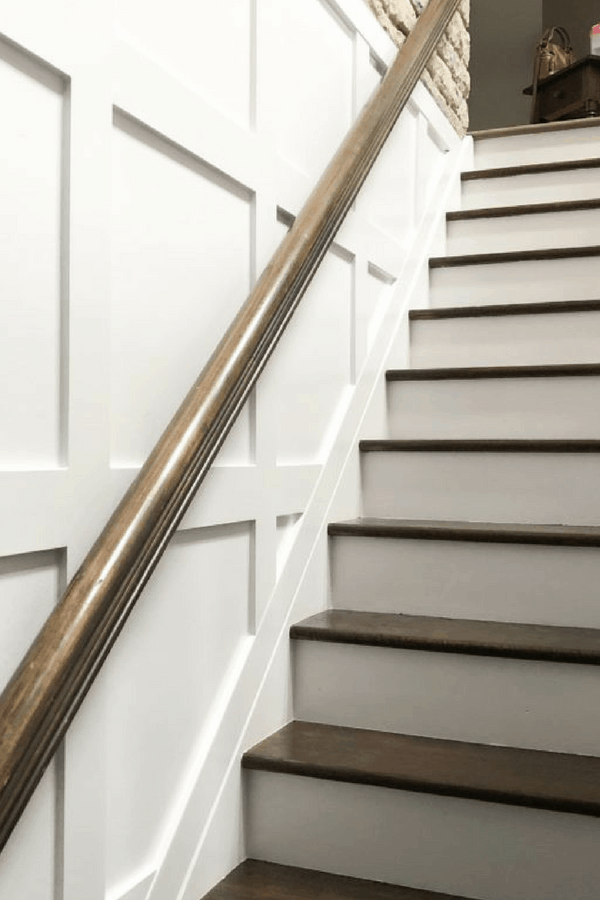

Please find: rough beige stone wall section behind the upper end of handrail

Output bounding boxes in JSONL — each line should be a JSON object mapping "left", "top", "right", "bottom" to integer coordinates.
{"left": 367, "top": 0, "right": 471, "bottom": 135}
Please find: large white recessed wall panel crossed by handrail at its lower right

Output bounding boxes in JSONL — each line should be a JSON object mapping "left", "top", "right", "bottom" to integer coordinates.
{"left": 111, "top": 115, "right": 253, "bottom": 466}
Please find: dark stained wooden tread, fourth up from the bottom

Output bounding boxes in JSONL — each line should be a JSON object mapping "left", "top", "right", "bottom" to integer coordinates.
{"left": 327, "top": 516, "right": 600, "bottom": 547}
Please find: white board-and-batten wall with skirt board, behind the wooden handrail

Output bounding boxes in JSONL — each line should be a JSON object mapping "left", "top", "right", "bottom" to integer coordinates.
{"left": 0, "top": 0, "right": 461, "bottom": 900}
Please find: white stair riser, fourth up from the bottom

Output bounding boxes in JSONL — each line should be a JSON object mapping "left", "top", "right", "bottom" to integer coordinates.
{"left": 361, "top": 450, "right": 600, "bottom": 525}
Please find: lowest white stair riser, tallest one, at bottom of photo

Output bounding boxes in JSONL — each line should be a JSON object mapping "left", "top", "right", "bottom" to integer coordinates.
{"left": 247, "top": 772, "right": 600, "bottom": 900}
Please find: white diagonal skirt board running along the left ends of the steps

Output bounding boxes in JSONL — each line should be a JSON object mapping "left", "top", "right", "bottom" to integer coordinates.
{"left": 135, "top": 105, "right": 473, "bottom": 900}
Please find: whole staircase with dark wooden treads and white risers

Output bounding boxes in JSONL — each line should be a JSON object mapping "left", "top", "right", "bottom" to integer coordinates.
{"left": 200, "top": 122, "right": 600, "bottom": 900}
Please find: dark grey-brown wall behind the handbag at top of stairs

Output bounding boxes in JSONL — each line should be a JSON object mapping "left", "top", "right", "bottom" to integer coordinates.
{"left": 469, "top": 0, "right": 600, "bottom": 131}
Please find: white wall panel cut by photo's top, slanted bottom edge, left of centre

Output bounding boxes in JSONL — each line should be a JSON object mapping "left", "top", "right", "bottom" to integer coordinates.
{"left": 116, "top": 0, "right": 253, "bottom": 126}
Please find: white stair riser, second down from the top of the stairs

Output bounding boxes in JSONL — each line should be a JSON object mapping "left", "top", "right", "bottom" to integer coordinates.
{"left": 461, "top": 163, "right": 600, "bottom": 209}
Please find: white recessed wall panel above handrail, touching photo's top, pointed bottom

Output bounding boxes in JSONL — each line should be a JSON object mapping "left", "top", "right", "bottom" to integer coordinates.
{"left": 258, "top": 0, "right": 354, "bottom": 180}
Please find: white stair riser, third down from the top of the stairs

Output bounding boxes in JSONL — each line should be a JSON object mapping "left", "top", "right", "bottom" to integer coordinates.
{"left": 446, "top": 209, "right": 600, "bottom": 256}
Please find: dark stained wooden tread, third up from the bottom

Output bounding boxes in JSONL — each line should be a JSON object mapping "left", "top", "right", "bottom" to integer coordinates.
{"left": 290, "top": 609, "right": 600, "bottom": 666}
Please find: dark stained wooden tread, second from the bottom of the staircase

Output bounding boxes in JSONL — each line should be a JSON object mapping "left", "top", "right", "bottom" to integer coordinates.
{"left": 242, "top": 722, "right": 600, "bottom": 816}
